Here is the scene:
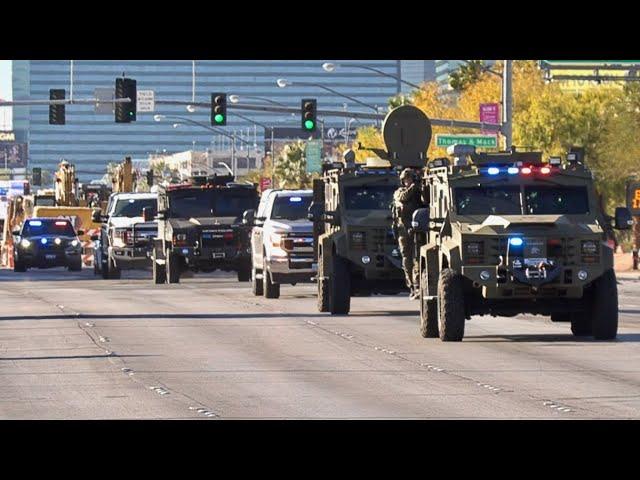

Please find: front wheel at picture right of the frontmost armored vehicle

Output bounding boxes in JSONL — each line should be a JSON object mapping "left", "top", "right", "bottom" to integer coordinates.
{"left": 589, "top": 270, "right": 618, "bottom": 340}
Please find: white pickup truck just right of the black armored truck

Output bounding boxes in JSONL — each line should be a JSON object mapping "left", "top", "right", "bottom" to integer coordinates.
{"left": 244, "top": 190, "right": 317, "bottom": 298}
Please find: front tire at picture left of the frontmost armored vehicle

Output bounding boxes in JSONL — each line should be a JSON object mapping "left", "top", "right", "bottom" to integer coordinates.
{"left": 438, "top": 268, "right": 465, "bottom": 342}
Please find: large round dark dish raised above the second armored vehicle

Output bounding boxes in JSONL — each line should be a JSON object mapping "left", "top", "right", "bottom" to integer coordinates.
{"left": 382, "top": 105, "right": 431, "bottom": 167}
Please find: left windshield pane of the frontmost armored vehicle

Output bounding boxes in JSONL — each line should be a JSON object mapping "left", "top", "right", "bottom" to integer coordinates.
{"left": 455, "top": 187, "right": 522, "bottom": 215}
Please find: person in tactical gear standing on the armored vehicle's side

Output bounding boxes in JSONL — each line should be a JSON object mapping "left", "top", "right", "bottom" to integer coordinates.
{"left": 393, "top": 168, "right": 424, "bottom": 299}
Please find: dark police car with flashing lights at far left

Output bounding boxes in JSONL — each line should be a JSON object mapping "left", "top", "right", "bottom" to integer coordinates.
{"left": 13, "top": 218, "right": 84, "bottom": 272}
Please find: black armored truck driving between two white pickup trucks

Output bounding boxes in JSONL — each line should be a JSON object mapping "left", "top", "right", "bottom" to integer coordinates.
{"left": 152, "top": 175, "right": 258, "bottom": 283}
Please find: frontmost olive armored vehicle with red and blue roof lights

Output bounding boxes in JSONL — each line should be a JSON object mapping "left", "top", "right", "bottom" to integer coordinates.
{"left": 409, "top": 136, "right": 631, "bottom": 341}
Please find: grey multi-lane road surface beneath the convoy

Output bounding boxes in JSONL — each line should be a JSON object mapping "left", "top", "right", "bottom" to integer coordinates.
{"left": 0, "top": 269, "right": 640, "bottom": 420}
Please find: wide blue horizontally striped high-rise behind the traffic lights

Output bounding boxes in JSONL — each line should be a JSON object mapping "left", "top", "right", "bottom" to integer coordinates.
{"left": 13, "top": 60, "right": 400, "bottom": 181}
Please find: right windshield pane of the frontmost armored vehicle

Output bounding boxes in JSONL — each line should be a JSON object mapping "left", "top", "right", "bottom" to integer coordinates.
{"left": 524, "top": 186, "right": 589, "bottom": 215}
